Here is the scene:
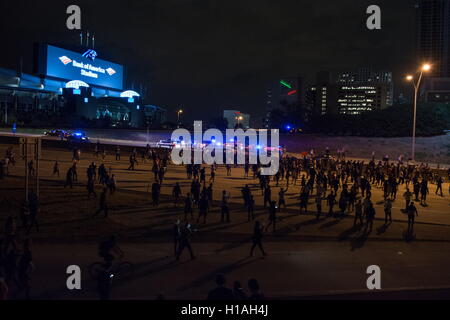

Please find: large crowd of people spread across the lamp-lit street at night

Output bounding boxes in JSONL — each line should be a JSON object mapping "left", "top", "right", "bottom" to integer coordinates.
{"left": 0, "top": 143, "right": 450, "bottom": 299}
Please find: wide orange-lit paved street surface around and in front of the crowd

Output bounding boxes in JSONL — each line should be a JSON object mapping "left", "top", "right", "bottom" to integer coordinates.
{"left": 0, "top": 141, "right": 450, "bottom": 299}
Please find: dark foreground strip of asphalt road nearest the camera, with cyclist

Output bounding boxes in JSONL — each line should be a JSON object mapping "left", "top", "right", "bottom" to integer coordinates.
{"left": 32, "top": 241, "right": 450, "bottom": 299}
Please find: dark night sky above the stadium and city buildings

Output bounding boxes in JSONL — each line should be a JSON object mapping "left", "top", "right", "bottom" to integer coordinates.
{"left": 0, "top": 0, "right": 415, "bottom": 124}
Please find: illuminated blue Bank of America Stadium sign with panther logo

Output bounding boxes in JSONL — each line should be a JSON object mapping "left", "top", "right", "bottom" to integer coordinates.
{"left": 45, "top": 45, "right": 123, "bottom": 90}
